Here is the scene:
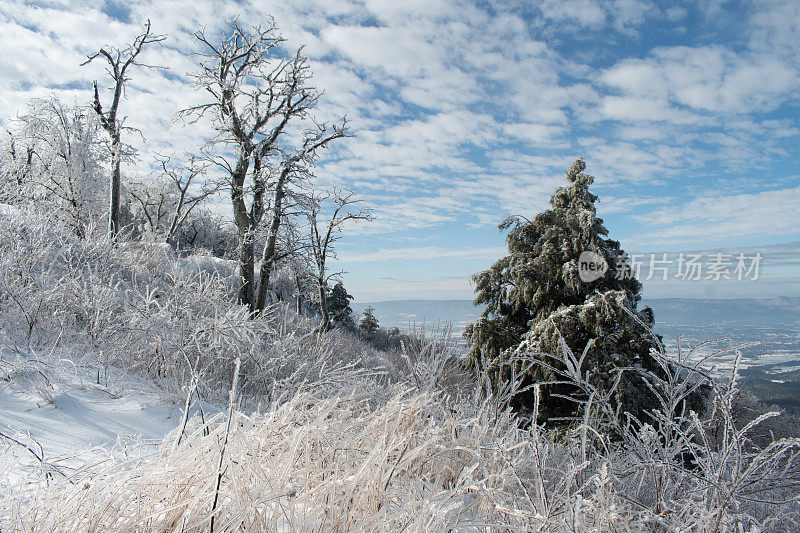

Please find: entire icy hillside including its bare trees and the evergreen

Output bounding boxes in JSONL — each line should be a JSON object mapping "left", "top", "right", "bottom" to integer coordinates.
{"left": 0, "top": 12, "right": 800, "bottom": 533}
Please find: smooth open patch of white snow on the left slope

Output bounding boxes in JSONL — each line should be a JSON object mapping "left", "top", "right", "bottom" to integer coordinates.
{"left": 0, "top": 335, "right": 215, "bottom": 496}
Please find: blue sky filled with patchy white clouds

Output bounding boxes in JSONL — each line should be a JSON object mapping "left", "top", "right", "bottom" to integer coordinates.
{"left": 0, "top": 0, "right": 800, "bottom": 301}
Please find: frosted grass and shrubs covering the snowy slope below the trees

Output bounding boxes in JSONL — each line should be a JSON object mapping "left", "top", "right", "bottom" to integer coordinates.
{"left": 0, "top": 209, "right": 800, "bottom": 531}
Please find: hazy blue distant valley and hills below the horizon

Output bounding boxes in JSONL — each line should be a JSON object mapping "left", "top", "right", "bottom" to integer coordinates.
{"left": 352, "top": 297, "right": 800, "bottom": 414}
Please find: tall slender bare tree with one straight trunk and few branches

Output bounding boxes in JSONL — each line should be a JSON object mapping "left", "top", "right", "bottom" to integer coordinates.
{"left": 81, "top": 19, "right": 166, "bottom": 238}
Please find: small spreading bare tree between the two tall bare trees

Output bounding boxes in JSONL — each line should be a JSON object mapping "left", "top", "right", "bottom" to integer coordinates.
{"left": 130, "top": 156, "right": 220, "bottom": 245}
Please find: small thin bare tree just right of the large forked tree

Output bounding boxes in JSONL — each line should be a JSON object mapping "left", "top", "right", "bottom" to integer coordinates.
{"left": 308, "top": 189, "right": 373, "bottom": 330}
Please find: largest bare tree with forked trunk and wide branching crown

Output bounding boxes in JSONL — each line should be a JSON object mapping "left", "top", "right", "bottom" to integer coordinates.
{"left": 188, "top": 20, "right": 347, "bottom": 312}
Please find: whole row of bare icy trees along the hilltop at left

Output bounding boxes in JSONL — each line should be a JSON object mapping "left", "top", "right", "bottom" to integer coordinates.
{"left": 2, "top": 18, "right": 372, "bottom": 329}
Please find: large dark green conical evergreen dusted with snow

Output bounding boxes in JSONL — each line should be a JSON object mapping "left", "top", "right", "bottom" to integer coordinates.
{"left": 465, "top": 159, "right": 700, "bottom": 423}
